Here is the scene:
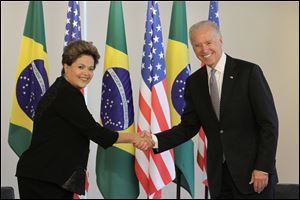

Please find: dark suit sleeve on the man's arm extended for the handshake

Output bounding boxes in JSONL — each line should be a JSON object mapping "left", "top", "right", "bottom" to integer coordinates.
{"left": 155, "top": 79, "right": 201, "bottom": 153}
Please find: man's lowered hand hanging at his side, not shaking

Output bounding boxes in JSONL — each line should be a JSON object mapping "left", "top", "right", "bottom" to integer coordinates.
{"left": 249, "top": 169, "right": 269, "bottom": 193}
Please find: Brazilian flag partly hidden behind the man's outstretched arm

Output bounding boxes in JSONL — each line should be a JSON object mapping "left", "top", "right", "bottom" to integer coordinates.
{"left": 166, "top": 1, "right": 195, "bottom": 198}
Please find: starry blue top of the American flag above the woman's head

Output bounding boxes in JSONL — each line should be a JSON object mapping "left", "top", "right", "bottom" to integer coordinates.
{"left": 64, "top": 1, "right": 81, "bottom": 46}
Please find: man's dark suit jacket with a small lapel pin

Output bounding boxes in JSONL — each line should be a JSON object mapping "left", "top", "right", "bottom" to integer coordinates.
{"left": 156, "top": 56, "right": 278, "bottom": 197}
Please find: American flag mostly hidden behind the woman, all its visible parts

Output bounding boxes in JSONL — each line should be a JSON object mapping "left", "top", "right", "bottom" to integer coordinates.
{"left": 64, "top": 1, "right": 89, "bottom": 199}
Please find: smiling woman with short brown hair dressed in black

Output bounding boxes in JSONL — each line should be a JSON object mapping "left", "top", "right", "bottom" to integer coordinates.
{"left": 16, "top": 40, "right": 150, "bottom": 198}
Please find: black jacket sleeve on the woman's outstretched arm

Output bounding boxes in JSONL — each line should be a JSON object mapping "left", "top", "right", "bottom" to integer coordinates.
{"left": 55, "top": 88, "right": 118, "bottom": 148}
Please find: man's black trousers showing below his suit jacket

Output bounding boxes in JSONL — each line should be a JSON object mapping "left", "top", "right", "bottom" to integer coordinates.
{"left": 216, "top": 161, "right": 275, "bottom": 199}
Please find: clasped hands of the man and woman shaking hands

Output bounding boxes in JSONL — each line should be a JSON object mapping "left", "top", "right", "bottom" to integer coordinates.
{"left": 132, "top": 131, "right": 155, "bottom": 151}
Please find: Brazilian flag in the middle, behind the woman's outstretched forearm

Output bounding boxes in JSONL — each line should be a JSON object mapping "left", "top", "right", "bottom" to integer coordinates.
{"left": 96, "top": 1, "right": 139, "bottom": 199}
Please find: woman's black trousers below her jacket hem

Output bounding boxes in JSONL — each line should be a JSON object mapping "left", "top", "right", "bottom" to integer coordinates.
{"left": 18, "top": 177, "right": 74, "bottom": 199}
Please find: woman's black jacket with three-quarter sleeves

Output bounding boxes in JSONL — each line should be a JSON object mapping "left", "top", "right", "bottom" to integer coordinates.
{"left": 16, "top": 77, "right": 118, "bottom": 194}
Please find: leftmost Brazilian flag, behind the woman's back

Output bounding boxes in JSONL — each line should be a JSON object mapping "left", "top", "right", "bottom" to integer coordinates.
{"left": 8, "top": 1, "right": 49, "bottom": 156}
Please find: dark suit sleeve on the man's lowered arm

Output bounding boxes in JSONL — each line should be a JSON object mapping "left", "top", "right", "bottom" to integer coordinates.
{"left": 249, "top": 65, "right": 278, "bottom": 173}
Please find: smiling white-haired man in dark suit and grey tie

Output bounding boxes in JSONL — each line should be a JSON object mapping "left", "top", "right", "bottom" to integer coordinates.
{"left": 152, "top": 21, "right": 278, "bottom": 199}
